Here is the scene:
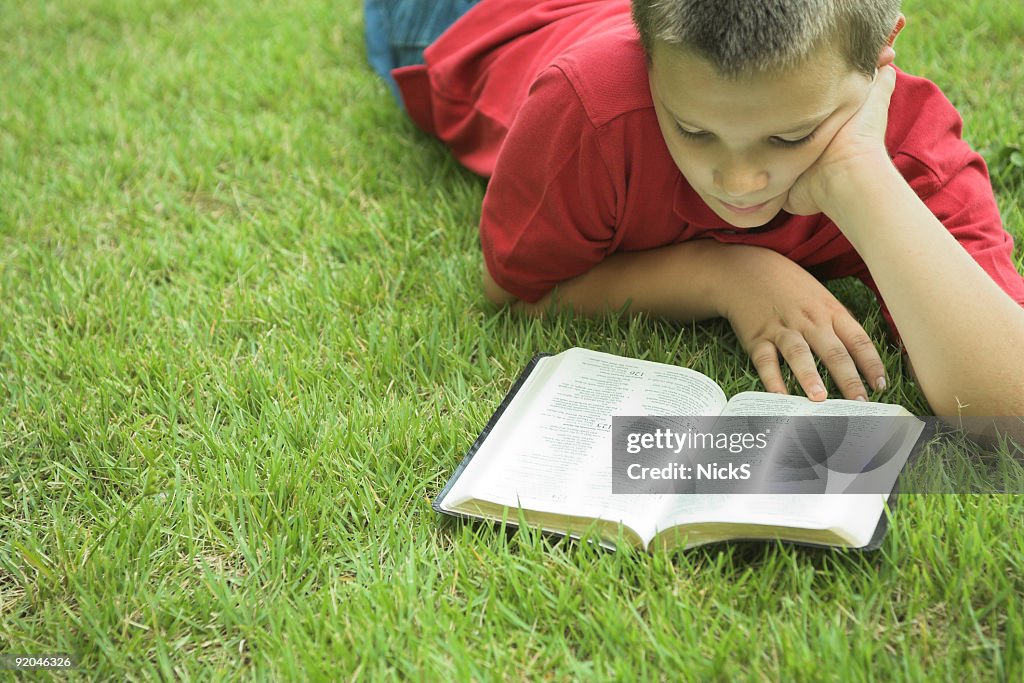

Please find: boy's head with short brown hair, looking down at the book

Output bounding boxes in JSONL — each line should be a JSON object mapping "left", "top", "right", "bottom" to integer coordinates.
{"left": 633, "top": 0, "right": 902, "bottom": 227}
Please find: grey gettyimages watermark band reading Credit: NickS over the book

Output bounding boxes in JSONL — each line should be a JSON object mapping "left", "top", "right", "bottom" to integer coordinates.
{"left": 612, "top": 416, "right": 1024, "bottom": 494}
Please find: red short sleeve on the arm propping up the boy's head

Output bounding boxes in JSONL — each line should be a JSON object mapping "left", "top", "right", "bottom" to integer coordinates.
{"left": 861, "top": 151, "right": 1024, "bottom": 340}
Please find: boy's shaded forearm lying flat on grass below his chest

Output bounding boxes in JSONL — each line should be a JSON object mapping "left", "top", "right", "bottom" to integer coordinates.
{"left": 484, "top": 240, "right": 736, "bottom": 322}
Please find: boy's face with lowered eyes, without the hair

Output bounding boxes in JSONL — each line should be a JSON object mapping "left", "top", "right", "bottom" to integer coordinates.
{"left": 650, "top": 41, "right": 871, "bottom": 227}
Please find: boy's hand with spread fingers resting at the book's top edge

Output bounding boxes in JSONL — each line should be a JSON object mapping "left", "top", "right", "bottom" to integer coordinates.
{"left": 720, "top": 245, "right": 885, "bottom": 400}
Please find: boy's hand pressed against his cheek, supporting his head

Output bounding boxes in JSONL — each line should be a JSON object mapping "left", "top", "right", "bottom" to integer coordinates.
{"left": 783, "top": 66, "right": 896, "bottom": 216}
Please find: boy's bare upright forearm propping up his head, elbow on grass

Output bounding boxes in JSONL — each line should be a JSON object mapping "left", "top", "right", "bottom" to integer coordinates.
{"left": 822, "top": 159, "right": 1024, "bottom": 416}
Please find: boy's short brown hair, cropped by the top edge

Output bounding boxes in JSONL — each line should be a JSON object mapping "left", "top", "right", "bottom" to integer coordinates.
{"left": 633, "top": 0, "right": 900, "bottom": 78}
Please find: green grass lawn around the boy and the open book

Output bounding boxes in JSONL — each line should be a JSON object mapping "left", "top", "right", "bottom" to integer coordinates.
{"left": 0, "top": 0, "right": 1024, "bottom": 680}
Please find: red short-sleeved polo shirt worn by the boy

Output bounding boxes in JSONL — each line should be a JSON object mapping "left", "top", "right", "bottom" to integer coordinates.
{"left": 393, "top": 0, "right": 1024, "bottom": 342}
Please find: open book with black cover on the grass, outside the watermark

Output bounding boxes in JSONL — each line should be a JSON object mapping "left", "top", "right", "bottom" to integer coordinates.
{"left": 433, "top": 348, "right": 925, "bottom": 550}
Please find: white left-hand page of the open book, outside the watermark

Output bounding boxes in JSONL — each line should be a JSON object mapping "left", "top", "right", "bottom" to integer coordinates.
{"left": 444, "top": 349, "right": 726, "bottom": 536}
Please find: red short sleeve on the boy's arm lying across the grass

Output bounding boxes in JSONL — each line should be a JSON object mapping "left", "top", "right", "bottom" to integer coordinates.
{"left": 480, "top": 67, "right": 616, "bottom": 302}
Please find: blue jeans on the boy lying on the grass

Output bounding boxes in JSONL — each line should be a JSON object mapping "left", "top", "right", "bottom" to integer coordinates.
{"left": 362, "top": 0, "right": 476, "bottom": 103}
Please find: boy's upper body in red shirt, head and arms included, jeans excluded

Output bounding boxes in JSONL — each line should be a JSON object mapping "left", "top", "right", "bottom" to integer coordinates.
{"left": 368, "top": 0, "right": 1024, "bottom": 416}
